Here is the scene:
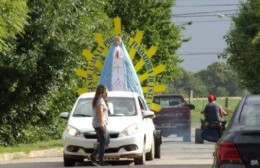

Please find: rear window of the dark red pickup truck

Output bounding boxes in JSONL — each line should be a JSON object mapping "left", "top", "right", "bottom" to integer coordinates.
{"left": 154, "top": 97, "right": 183, "bottom": 107}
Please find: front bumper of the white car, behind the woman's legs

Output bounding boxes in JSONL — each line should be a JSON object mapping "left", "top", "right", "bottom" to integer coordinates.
{"left": 63, "top": 133, "right": 144, "bottom": 160}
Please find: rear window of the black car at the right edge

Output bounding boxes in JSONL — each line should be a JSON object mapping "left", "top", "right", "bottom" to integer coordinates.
{"left": 243, "top": 104, "right": 260, "bottom": 126}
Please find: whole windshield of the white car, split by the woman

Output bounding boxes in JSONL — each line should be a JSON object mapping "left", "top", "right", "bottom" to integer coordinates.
{"left": 73, "top": 97, "right": 137, "bottom": 117}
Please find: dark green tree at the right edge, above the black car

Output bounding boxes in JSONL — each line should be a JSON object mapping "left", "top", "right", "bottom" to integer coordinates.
{"left": 222, "top": 0, "right": 260, "bottom": 93}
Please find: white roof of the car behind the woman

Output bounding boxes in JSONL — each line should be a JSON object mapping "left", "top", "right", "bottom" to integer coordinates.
{"left": 79, "top": 91, "right": 139, "bottom": 98}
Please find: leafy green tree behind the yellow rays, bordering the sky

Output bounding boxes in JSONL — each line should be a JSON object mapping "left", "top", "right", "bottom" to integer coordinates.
{"left": 106, "top": 0, "right": 183, "bottom": 83}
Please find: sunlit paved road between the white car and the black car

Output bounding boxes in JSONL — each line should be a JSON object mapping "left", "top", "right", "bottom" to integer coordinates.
{"left": 147, "top": 128, "right": 215, "bottom": 167}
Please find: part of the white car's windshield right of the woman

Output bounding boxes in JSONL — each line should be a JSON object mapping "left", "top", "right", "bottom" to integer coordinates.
{"left": 108, "top": 97, "right": 137, "bottom": 116}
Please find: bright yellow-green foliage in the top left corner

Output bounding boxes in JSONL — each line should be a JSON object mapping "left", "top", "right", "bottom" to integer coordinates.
{"left": 0, "top": 0, "right": 29, "bottom": 52}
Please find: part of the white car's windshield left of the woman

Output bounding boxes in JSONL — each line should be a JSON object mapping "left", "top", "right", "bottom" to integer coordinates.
{"left": 73, "top": 99, "right": 92, "bottom": 117}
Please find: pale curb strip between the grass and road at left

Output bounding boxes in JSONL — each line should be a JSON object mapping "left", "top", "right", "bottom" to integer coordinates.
{"left": 0, "top": 147, "right": 63, "bottom": 162}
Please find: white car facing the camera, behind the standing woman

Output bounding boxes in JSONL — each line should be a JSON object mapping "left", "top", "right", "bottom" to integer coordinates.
{"left": 60, "top": 91, "right": 161, "bottom": 166}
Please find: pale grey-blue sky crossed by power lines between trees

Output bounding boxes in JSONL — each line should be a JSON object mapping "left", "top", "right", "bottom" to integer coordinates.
{"left": 172, "top": 0, "right": 244, "bottom": 72}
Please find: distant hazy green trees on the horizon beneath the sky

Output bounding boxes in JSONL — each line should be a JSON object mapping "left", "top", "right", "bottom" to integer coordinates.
{"left": 171, "top": 62, "right": 245, "bottom": 97}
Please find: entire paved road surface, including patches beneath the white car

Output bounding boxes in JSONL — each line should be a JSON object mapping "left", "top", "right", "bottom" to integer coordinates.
{"left": 0, "top": 126, "right": 215, "bottom": 168}
